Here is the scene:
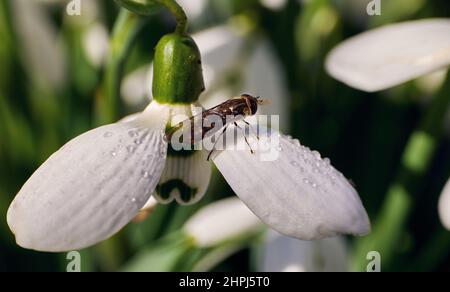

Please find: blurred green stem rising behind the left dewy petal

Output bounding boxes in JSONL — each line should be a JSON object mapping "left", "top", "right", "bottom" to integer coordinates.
{"left": 96, "top": 10, "right": 146, "bottom": 124}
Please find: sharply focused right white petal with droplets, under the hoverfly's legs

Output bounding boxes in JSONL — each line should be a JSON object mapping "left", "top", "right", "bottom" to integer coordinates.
{"left": 214, "top": 129, "right": 370, "bottom": 240}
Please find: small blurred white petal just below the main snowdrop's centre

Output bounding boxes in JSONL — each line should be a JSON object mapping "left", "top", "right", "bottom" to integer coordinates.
{"left": 184, "top": 198, "right": 262, "bottom": 247}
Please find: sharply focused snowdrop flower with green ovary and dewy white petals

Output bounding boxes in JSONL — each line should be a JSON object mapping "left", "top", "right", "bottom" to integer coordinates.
{"left": 7, "top": 27, "right": 370, "bottom": 252}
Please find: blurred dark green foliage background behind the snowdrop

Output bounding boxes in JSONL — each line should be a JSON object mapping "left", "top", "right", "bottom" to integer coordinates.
{"left": 0, "top": 0, "right": 450, "bottom": 271}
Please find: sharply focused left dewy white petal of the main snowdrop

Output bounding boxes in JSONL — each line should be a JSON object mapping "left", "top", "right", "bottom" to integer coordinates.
{"left": 7, "top": 103, "right": 168, "bottom": 252}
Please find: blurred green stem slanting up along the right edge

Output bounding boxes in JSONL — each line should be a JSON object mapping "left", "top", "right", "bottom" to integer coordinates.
{"left": 353, "top": 73, "right": 450, "bottom": 271}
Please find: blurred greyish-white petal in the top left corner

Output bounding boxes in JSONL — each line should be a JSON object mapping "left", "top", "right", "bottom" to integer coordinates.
{"left": 11, "top": 0, "right": 67, "bottom": 89}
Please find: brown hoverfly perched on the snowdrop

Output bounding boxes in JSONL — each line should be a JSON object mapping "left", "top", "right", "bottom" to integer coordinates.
{"left": 166, "top": 94, "right": 266, "bottom": 160}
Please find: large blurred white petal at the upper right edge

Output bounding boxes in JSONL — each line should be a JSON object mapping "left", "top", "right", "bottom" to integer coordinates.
{"left": 326, "top": 19, "right": 450, "bottom": 92}
